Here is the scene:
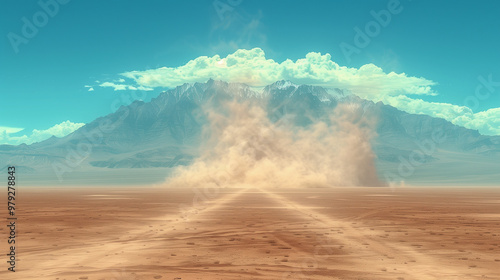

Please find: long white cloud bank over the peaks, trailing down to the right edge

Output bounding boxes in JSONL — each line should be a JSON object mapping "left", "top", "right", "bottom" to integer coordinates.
{"left": 121, "top": 48, "right": 500, "bottom": 135}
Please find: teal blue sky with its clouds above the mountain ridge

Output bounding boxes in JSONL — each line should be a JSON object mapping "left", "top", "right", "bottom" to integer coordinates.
{"left": 0, "top": 0, "right": 500, "bottom": 144}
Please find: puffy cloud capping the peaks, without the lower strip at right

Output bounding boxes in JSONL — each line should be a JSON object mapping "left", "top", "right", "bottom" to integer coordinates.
{"left": 122, "top": 48, "right": 435, "bottom": 97}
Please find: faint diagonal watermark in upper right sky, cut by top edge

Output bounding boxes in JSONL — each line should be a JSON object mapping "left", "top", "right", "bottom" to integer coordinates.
{"left": 339, "top": 0, "right": 411, "bottom": 63}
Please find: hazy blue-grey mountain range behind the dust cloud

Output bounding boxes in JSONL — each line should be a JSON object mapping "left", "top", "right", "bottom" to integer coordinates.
{"left": 0, "top": 80, "right": 500, "bottom": 185}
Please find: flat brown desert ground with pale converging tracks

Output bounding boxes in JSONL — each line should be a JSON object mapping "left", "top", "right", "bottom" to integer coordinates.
{"left": 0, "top": 188, "right": 500, "bottom": 280}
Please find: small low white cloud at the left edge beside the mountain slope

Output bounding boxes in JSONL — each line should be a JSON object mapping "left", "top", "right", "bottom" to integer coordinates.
{"left": 0, "top": 121, "right": 85, "bottom": 145}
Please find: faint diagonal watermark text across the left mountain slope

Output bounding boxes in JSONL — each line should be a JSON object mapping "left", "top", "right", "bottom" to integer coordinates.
{"left": 52, "top": 91, "right": 146, "bottom": 182}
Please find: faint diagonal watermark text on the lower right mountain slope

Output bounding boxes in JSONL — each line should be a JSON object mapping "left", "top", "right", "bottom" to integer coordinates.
{"left": 384, "top": 128, "right": 447, "bottom": 188}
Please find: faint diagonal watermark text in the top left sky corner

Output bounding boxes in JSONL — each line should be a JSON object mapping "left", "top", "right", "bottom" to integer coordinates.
{"left": 7, "top": 0, "right": 70, "bottom": 54}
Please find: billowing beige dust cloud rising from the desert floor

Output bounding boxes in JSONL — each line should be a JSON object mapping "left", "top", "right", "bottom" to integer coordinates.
{"left": 167, "top": 98, "right": 384, "bottom": 188}
